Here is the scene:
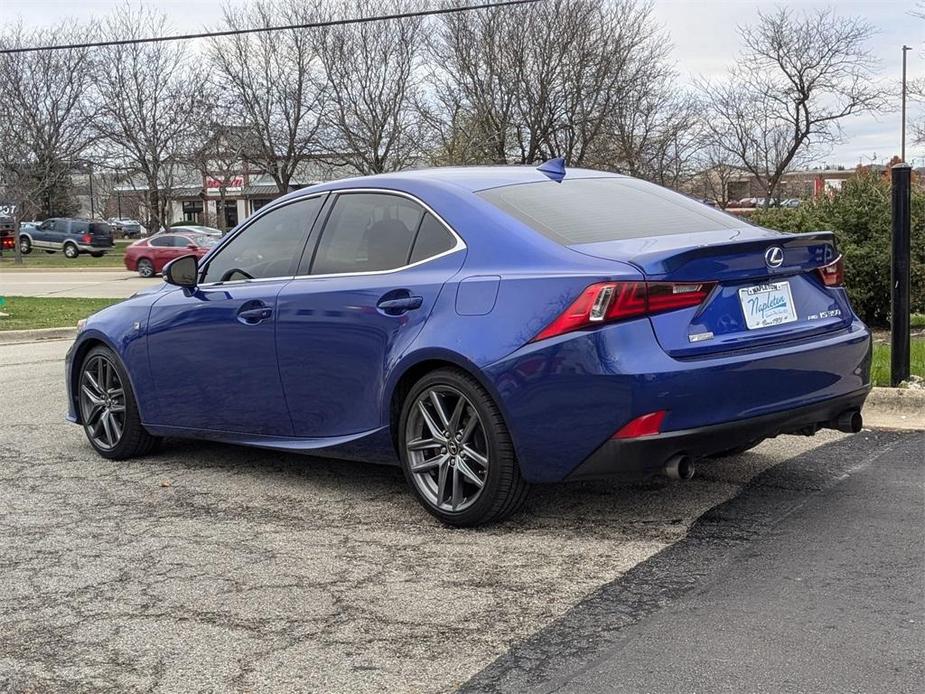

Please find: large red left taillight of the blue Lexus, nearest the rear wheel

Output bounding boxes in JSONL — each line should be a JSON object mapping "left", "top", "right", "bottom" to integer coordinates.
{"left": 533, "top": 282, "right": 716, "bottom": 342}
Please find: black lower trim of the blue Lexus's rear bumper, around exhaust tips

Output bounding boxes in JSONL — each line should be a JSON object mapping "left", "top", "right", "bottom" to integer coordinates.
{"left": 566, "top": 387, "right": 870, "bottom": 480}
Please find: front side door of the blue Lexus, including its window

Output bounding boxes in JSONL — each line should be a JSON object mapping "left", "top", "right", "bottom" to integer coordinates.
{"left": 147, "top": 197, "right": 322, "bottom": 436}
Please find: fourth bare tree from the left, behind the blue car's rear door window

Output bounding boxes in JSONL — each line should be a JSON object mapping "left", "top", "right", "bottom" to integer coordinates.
{"left": 318, "top": 0, "right": 423, "bottom": 174}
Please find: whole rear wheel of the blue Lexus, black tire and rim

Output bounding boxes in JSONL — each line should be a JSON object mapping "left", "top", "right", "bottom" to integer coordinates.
{"left": 399, "top": 368, "right": 528, "bottom": 527}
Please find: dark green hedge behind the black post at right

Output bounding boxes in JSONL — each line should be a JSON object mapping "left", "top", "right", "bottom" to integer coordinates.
{"left": 751, "top": 172, "right": 925, "bottom": 326}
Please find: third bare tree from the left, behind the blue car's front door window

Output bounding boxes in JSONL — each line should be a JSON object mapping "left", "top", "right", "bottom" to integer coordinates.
{"left": 209, "top": 0, "right": 325, "bottom": 193}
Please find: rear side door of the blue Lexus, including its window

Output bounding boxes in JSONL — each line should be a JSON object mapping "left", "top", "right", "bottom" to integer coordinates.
{"left": 277, "top": 192, "right": 465, "bottom": 437}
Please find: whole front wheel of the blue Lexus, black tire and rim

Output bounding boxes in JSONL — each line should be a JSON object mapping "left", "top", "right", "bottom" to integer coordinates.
{"left": 77, "top": 346, "right": 159, "bottom": 460}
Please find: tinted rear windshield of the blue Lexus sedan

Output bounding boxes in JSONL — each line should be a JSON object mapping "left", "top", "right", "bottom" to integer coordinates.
{"left": 478, "top": 178, "right": 744, "bottom": 246}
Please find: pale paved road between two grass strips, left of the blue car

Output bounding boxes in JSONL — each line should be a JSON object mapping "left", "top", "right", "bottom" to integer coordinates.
{"left": 0, "top": 270, "right": 157, "bottom": 299}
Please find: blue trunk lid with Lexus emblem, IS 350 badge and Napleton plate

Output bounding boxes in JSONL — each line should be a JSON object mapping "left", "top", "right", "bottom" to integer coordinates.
{"left": 571, "top": 227, "right": 851, "bottom": 357}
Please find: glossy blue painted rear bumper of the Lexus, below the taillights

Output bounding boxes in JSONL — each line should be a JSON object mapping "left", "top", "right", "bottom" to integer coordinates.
{"left": 484, "top": 319, "right": 871, "bottom": 482}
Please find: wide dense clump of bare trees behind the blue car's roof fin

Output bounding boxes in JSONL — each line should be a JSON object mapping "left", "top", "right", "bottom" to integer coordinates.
{"left": 428, "top": 0, "right": 679, "bottom": 178}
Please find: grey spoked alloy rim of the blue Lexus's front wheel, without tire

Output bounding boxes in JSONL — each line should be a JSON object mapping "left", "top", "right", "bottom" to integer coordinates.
{"left": 80, "top": 354, "right": 125, "bottom": 450}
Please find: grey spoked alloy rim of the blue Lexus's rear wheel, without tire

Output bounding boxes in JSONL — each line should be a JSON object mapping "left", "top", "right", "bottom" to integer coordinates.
{"left": 405, "top": 386, "right": 490, "bottom": 512}
